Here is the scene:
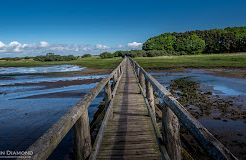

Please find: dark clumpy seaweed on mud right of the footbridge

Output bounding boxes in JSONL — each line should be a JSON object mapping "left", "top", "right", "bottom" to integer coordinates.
{"left": 170, "top": 77, "right": 246, "bottom": 120}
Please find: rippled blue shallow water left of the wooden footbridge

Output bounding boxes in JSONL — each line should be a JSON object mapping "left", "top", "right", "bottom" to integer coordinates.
{"left": 0, "top": 65, "right": 107, "bottom": 159}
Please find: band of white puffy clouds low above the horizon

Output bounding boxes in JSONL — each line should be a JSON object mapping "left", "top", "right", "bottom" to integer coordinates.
{"left": 0, "top": 41, "right": 142, "bottom": 57}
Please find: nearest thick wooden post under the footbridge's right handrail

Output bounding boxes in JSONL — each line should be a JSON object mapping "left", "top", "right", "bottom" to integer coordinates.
{"left": 162, "top": 106, "right": 181, "bottom": 160}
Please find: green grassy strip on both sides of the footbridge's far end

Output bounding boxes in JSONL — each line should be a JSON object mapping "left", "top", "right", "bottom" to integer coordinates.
{"left": 0, "top": 53, "right": 246, "bottom": 69}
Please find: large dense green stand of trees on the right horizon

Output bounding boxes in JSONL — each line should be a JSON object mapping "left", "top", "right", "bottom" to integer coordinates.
{"left": 142, "top": 27, "right": 246, "bottom": 54}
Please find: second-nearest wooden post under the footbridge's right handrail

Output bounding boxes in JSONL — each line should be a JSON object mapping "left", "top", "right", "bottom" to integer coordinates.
{"left": 145, "top": 78, "right": 156, "bottom": 120}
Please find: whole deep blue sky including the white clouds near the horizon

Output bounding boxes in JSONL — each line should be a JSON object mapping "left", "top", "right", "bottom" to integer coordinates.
{"left": 0, "top": 0, "right": 246, "bottom": 57}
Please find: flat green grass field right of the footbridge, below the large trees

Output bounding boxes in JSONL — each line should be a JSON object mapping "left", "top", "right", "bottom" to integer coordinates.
{"left": 135, "top": 53, "right": 246, "bottom": 69}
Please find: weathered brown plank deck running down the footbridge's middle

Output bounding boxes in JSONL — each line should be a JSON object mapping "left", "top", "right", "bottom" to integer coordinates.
{"left": 97, "top": 60, "right": 161, "bottom": 159}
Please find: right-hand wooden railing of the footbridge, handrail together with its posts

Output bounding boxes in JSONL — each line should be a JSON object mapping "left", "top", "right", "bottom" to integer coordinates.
{"left": 130, "top": 58, "right": 237, "bottom": 160}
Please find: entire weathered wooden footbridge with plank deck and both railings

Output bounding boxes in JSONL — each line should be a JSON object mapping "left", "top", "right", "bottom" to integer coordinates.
{"left": 22, "top": 57, "right": 237, "bottom": 160}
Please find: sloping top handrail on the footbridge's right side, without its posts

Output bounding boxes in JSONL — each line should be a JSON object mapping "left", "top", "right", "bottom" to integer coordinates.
{"left": 129, "top": 58, "right": 237, "bottom": 160}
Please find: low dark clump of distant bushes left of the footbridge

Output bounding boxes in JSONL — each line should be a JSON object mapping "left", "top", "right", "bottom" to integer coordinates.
{"left": 33, "top": 53, "right": 79, "bottom": 62}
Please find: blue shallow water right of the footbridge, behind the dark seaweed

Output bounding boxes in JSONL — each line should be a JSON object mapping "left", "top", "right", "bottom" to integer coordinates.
{"left": 151, "top": 69, "right": 246, "bottom": 96}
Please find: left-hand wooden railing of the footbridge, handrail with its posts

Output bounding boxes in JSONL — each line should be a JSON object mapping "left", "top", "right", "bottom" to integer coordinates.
{"left": 19, "top": 58, "right": 126, "bottom": 160}
